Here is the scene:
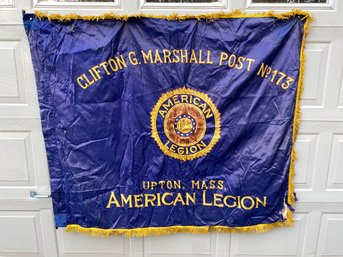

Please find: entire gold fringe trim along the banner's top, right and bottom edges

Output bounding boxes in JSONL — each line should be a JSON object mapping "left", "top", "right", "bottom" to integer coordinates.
{"left": 35, "top": 10, "right": 314, "bottom": 237}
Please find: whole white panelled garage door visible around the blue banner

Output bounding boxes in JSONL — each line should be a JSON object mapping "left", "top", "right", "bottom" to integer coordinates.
{"left": 0, "top": 0, "right": 343, "bottom": 257}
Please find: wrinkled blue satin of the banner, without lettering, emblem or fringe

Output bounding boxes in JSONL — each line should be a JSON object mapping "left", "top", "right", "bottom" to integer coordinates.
{"left": 23, "top": 14, "right": 304, "bottom": 228}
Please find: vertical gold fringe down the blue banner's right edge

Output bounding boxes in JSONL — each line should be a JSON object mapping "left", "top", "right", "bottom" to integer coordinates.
{"left": 287, "top": 15, "right": 314, "bottom": 207}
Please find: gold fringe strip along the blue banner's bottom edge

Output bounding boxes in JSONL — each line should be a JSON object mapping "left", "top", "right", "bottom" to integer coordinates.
{"left": 66, "top": 206, "right": 294, "bottom": 237}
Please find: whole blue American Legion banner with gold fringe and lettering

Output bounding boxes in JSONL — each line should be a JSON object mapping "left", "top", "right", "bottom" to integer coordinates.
{"left": 23, "top": 10, "right": 311, "bottom": 236}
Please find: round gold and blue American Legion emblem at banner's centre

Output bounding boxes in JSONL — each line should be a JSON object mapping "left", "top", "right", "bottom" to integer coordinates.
{"left": 151, "top": 87, "right": 220, "bottom": 161}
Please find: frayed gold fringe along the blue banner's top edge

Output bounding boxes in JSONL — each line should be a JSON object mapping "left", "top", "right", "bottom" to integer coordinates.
{"left": 35, "top": 10, "right": 312, "bottom": 22}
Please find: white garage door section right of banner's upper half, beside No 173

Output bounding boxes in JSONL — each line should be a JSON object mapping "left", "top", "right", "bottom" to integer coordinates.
{"left": 301, "top": 27, "right": 343, "bottom": 121}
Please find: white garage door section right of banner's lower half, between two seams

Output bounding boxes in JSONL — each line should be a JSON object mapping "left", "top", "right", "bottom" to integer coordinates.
{"left": 295, "top": 121, "right": 343, "bottom": 202}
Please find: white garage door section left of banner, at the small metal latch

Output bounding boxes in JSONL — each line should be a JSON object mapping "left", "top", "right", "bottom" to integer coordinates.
{"left": 0, "top": 119, "right": 49, "bottom": 199}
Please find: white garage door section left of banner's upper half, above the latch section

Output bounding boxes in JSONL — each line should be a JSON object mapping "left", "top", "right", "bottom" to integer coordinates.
{"left": 0, "top": 23, "right": 39, "bottom": 118}
